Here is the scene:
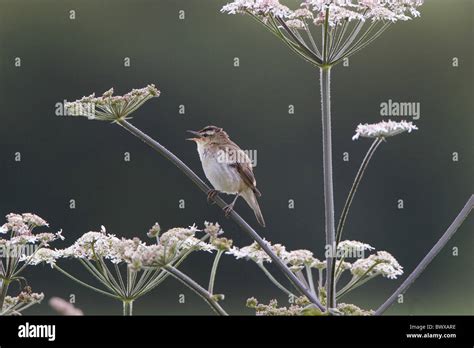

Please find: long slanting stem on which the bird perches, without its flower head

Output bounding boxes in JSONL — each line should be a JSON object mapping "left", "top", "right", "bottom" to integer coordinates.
{"left": 117, "top": 120, "right": 324, "bottom": 310}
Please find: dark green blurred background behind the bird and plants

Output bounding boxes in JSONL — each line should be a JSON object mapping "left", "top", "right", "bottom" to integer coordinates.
{"left": 0, "top": 0, "right": 474, "bottom": 314}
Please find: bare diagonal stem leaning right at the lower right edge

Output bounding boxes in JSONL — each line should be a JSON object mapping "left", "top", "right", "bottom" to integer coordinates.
{"left": 375, "top": 195, "right": 474, "bottom": 315}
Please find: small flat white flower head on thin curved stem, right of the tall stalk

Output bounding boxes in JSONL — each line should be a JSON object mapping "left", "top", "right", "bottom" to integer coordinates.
{"left": 352, "top": 120, "right": 418, "bottom": 140}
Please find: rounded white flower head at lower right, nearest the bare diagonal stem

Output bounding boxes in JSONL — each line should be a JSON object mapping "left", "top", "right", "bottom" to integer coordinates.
{"left": 351, "top": 251, "right": 403, "bottom": 279}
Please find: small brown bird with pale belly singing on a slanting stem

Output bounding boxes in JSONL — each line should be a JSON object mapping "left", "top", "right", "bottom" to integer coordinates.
{"left": 188, "top": 126, "right": 265, "bottom": 227}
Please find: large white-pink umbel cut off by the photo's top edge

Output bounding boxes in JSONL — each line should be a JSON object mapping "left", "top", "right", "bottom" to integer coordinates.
{"left": 221, "top": 0, "right": 423, "bottom": 68}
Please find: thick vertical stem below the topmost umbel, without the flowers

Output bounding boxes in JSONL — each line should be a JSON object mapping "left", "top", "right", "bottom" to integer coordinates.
{"left": 320, "top": 66, "right": 336, "bottom": 309}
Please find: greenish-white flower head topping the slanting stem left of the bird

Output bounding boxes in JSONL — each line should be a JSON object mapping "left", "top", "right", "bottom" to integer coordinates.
{"left": 65, "top": 84, "right": 160, "bottom": 122}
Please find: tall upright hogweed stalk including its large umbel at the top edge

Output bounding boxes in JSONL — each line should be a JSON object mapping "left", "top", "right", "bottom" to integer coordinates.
{"left": 221, "top": 0, "right": 423, "bottom": 309}
